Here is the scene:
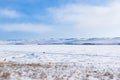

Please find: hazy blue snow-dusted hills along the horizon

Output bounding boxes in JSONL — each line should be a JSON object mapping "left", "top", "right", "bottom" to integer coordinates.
{"left": 0, "top": 37, "right": 120, "bottom": 45}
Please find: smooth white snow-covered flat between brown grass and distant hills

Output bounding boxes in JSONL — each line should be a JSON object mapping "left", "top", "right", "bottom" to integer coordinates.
{"left": 0, "top": 45, "right": 120, "bottom": 64}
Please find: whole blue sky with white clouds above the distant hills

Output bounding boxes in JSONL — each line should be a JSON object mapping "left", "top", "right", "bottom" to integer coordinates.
{"left": 0, "top": 0, "right": 120, "bottom": 40}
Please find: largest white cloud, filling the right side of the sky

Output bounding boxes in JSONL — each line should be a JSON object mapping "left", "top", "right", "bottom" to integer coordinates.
{"left": 48, "top": 0, "right": 120, "bottom": 36}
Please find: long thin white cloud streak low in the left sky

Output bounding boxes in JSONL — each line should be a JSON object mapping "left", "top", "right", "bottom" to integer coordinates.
{"left": 0, "top": 23, "right": 53, "bottom": 33}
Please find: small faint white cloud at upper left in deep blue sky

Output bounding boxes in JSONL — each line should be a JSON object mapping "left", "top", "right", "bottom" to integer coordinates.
{"left": 0, "top": 9, "right": 22, "bottom": 18}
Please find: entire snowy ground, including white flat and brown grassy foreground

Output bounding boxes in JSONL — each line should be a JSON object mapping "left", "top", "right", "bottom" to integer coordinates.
{"left": 0, "top": 45, "right": 120, "bottom": 80}
